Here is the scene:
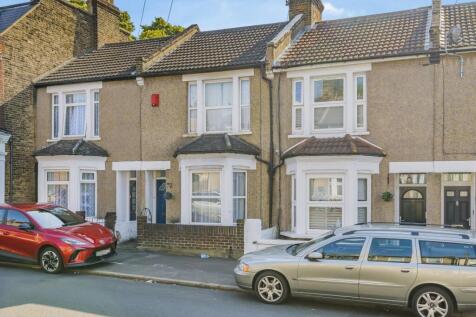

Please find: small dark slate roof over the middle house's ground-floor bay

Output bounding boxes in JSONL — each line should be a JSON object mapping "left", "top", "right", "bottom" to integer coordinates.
{"left": 175, "top": 134, "right": 260, "bottom": 157}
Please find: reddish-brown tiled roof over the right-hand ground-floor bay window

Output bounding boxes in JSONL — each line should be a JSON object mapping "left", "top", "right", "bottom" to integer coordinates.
{"left": 282, "top": 135, "right": 385, "bottom": 159}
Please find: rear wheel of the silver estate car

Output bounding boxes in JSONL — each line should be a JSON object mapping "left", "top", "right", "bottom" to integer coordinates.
{"left": 412, "top": 287, "right": 455, "bottom": 317}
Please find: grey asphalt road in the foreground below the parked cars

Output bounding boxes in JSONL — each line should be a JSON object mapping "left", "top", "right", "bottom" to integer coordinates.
{"left": 0, "top": 266, "right": 468, "bottom": 317}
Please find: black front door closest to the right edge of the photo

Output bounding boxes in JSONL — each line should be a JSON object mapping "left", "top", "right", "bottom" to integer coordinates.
{"left": 445, "top": 187, "right": 471, "bottom": 229}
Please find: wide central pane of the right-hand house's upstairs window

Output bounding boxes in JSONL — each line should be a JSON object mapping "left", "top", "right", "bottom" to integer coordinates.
{"left": 313, "top": 78, "right": 344, "bottom": 131}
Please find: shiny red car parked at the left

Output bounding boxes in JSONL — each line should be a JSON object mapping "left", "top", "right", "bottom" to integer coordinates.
{"left": 0, "top": 204, "right": 117, "bottom": 273}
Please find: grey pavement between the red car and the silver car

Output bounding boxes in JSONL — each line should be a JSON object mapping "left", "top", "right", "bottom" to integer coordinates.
{"left": 73, "top": 242, "right": 240, "bottom": 291}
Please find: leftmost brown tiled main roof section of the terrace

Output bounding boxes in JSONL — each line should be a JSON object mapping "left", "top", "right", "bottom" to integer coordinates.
{"left": 37, "top": 37, "right": 175, "bottom": 86}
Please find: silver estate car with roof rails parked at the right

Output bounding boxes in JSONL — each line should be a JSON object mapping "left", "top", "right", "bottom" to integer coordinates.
{"left": 235, "top": 224, "right": 476, "bottom": 317}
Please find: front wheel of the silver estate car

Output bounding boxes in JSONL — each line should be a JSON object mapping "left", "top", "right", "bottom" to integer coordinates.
{"left": 254, "top": 272, "right": 289, "bottom": 304}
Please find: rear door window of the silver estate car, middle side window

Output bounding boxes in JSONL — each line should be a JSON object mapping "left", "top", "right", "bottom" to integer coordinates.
{"left": 368, "top": 238, "right": 412, "bottom": 263}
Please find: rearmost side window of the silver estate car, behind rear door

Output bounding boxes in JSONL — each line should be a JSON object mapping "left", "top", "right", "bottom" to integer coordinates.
{"left": 420, "top": 241, "right": 476, "bottom": 266}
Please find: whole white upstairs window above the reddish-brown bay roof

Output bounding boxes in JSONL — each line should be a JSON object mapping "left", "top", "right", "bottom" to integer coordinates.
{"left": 287, "top": 64, "right": 372, "bottom": 138}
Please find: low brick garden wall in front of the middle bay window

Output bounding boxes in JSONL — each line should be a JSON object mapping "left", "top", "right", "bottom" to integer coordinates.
{"left": 137, "top": 216, "right": 245, "bottom": 259}
